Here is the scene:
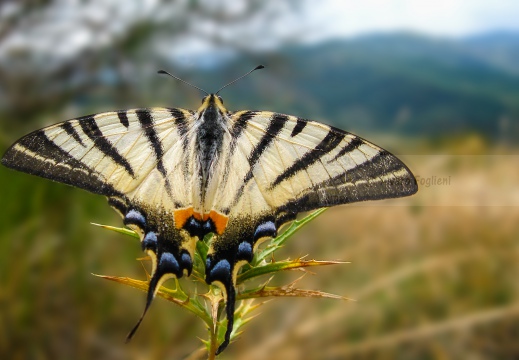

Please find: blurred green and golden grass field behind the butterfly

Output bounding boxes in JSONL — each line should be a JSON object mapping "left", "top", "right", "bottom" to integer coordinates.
{"left": 0, "top": 134, "right": 519, "bottom": 359}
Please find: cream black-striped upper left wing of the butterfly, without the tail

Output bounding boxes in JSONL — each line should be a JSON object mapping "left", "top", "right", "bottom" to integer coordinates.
{"left": 2, "top": 108, "right": 192, "bottom": 208}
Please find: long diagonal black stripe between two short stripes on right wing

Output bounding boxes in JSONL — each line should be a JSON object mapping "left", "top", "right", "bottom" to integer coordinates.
{"left": 270, "top": 129, "right": 345, "bottom": 189}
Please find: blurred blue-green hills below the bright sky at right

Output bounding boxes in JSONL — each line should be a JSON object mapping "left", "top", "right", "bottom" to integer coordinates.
{"left": 192, "top": 33, "right": 519, "bottom": 141}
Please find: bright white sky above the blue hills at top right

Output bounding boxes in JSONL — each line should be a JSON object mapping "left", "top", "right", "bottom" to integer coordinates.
{"left": 308, "top": 0, "right": 519, "bottom": 40}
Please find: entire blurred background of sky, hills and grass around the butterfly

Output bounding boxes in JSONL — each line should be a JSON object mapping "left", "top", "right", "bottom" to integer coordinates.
{"left": 0, "top": 0, "right": 519, "bottom": 359}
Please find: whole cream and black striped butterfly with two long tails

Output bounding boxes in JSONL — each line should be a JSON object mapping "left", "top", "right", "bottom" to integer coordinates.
{"left": 2, "top": 66, "right": 418, "bottom": 353}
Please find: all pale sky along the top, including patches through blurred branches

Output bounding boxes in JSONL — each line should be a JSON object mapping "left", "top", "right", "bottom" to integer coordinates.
{"left": 0, "top": 0, "right": 519, "bottom": 64}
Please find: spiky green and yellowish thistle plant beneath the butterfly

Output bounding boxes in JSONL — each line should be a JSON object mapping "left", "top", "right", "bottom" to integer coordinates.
{"left": 93, "top": 209, "right": 349, "bottom": 359}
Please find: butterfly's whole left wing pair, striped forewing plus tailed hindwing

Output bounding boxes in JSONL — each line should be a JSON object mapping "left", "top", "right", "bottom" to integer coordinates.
{"left": 2, "top": 108, "right": 203, "bottom": 332}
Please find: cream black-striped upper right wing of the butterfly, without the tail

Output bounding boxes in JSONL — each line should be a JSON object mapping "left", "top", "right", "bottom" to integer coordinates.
{"left": 213, "top": 112, "right": 417, "bottom": 219}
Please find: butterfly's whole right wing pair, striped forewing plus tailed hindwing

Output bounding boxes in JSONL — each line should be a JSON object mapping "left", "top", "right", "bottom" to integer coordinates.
{"left": 206, "top": 111, "right": 418, "bottom": 352}
